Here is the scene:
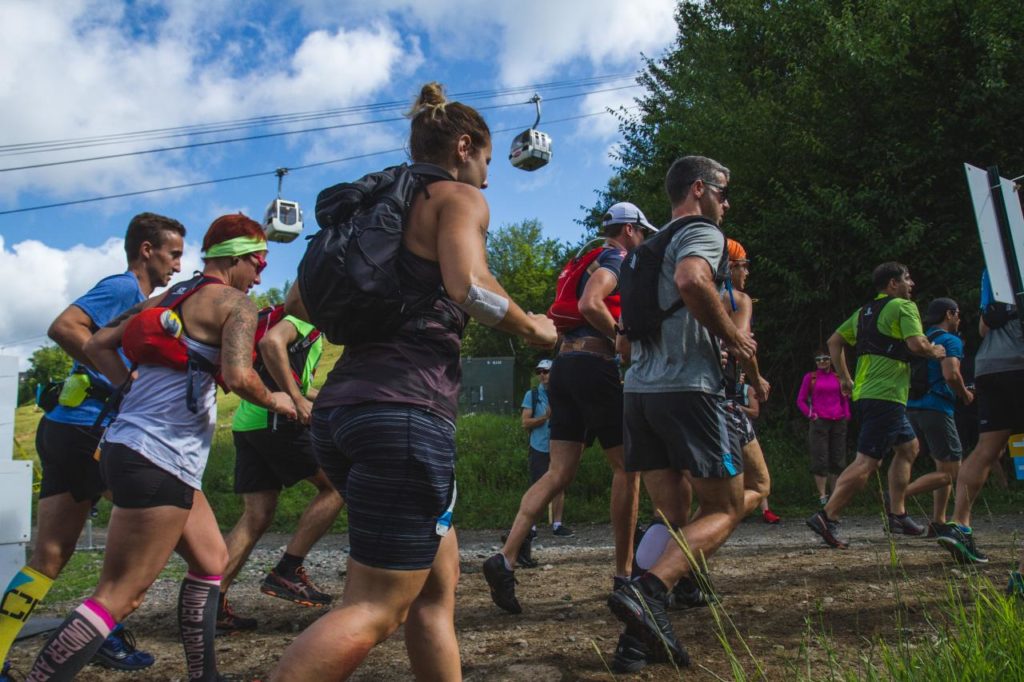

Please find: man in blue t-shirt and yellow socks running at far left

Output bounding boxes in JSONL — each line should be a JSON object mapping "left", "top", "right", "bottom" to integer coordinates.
{"left": 0, "top": 213, "right": 185, "bottom": 680}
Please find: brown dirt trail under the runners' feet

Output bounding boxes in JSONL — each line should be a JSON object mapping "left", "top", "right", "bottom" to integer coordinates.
{"left": 11, "top": 516, "right": 1024, "bottom": 682}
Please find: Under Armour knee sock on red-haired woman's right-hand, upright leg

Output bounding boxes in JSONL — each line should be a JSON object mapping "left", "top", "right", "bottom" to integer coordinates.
{"left": 178, "top": 572, "right": 220, "bottom": 682}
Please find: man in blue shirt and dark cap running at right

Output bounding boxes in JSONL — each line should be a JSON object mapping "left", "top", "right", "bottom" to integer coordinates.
{"left": 906, "top": 298, "right": 974, "bottom": 538}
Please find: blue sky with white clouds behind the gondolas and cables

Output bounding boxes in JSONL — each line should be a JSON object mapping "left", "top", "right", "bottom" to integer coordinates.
{"left": 0, "top": 0, "right": 675, "bottom": 358}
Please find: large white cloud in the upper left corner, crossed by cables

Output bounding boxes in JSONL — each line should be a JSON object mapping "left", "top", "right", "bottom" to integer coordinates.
{"left": 0, "top": 0, "right": 415, "bottom": 202}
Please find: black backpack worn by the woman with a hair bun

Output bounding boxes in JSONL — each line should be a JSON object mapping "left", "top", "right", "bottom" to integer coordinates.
{"left": 297, "top": 164, "right": 455, "bottom": 344}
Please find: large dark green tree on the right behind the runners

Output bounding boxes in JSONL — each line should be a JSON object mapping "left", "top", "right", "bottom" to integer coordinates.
{"left": 598, "top": 0, "right": 1024, "bottom": 413}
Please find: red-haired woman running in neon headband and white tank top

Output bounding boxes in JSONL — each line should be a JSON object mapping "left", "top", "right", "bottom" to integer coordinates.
{"left": 28, "top": 214, "right": 295, "bottom": 682}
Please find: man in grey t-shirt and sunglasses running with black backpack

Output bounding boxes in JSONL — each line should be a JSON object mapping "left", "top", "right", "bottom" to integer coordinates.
{"left": 608, "top": 157, "right": 768, "bottom": 665}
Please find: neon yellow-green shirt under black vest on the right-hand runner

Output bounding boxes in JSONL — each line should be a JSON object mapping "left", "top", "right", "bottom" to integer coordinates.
{"left": 836, "top": 294, "right": 925, "bottom": 404}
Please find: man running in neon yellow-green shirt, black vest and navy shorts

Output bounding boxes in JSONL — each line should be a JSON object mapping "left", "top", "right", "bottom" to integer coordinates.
{"left": 807, "top": 262, "right": 946, "bottom": 549}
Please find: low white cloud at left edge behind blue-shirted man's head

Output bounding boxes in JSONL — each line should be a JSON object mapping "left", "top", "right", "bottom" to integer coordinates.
{"left": 0, "top": 236, "right": 201, "bottom": 369}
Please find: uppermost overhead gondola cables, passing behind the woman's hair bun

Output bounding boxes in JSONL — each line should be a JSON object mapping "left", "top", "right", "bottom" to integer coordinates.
{"left": 0, "top": 74, "right": 635, "bottom": 156}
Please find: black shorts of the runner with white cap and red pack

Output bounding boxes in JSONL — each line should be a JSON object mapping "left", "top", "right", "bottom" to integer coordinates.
{"left": 548, "top": 353, "right": 623, "bottom": 450}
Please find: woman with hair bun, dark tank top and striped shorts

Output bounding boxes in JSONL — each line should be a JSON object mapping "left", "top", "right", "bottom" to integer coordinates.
{"left": 271, "top": 83, "right": 555, "bottom": 682}
